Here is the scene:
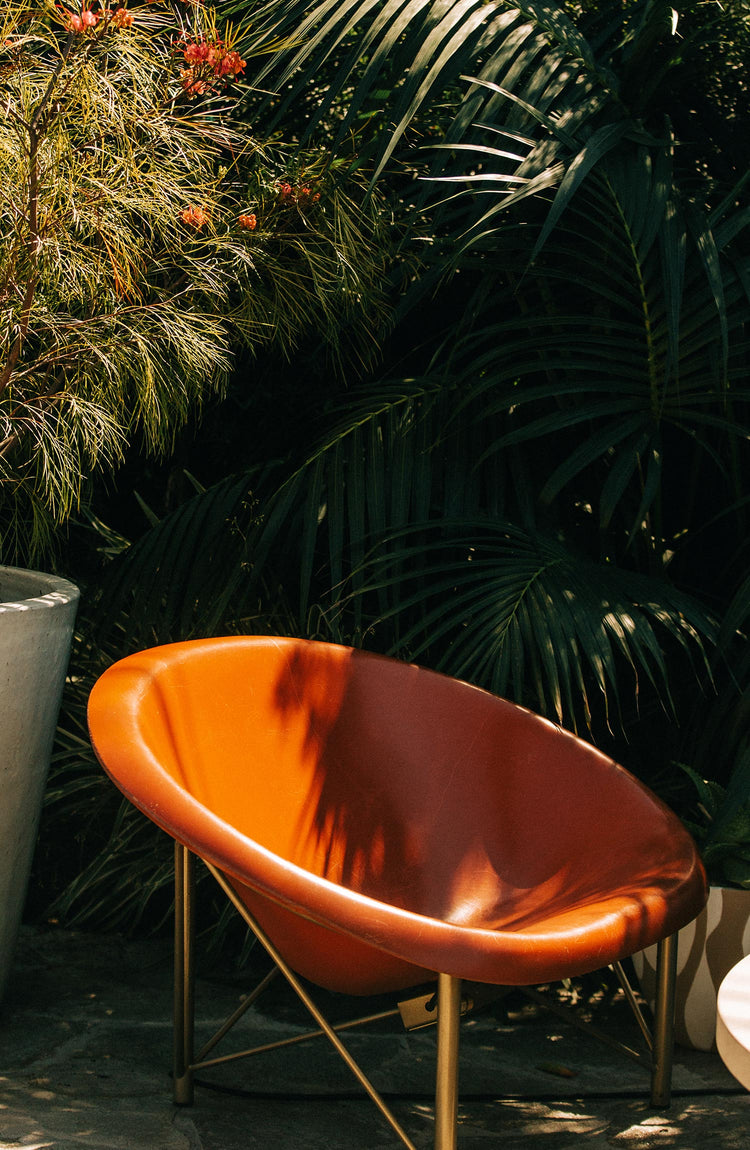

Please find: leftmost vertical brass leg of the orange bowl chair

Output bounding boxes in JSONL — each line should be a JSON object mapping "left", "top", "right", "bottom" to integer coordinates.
{"left": 173, "top": 842, "right": 196, "bottom": 1106}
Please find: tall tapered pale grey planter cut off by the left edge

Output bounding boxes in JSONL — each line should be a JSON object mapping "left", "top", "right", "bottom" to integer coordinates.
{"left": 0, "top": 567, "right": 78, "bottom": 997}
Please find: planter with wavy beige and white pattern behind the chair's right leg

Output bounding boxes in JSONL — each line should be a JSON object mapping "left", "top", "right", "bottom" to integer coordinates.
{"left": 633, "top": 887, "right": 750, "bottom": 1050}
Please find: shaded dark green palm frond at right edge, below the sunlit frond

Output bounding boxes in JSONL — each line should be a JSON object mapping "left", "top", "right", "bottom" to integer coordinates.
{"left": 427, "top": 141, "right": 750, "bottom": 536}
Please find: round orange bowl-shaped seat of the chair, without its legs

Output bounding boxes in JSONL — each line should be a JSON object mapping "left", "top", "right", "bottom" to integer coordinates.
{"left": 90, "top": 637, "right": 704, "bottom": 982}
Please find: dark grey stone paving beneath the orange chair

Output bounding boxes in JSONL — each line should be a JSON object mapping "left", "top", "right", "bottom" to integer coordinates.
{"left": 0, "top": 927, "right": 750, "bottom": 1150}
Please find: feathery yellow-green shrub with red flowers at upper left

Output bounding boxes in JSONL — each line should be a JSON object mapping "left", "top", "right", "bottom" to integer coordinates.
{"left": 0, "top": 0, "right": 383, "bottom": 562}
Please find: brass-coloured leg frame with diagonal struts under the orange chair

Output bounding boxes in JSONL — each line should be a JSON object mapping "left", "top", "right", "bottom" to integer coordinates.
{"left": 173, "top": 843, "right": 676, "bottom": 1150}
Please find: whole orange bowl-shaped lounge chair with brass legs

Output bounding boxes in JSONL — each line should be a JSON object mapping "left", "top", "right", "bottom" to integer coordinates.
{"left": 89, "top": 637, "right": 705, "bottom": 1150}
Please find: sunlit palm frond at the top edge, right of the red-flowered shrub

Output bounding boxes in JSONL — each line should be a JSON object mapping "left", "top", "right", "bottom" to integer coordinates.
{"left": 246, "top": 0, "right": 609, "bottom": 175}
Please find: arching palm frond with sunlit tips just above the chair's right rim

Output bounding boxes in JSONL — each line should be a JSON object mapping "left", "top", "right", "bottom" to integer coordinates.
{"left": 349, "top": 519, "right": 715, "bottom": 726}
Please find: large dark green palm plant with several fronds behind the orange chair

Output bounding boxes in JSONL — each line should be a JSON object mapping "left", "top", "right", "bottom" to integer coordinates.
{"left": 230, "top": 0, "right": 750, "bottom": 723}
